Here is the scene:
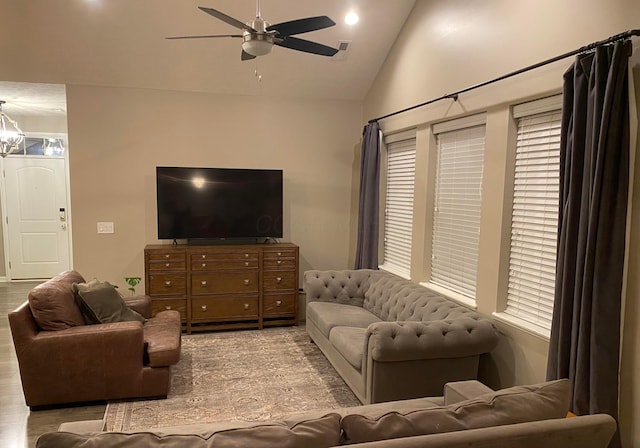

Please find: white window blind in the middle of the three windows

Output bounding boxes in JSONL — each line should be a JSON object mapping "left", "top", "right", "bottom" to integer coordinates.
{"left": 430, "top": 125, "right": 485, "bottom": 300}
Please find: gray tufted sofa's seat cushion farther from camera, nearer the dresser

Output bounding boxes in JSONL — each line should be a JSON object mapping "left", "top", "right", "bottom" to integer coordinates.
{"left": 307, "top": 302, "right": 380, "bottom": 339}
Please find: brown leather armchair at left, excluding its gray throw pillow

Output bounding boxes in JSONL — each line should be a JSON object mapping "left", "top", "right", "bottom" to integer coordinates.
{"left": 9, "top": 271, "right": 182, "bottom": 409}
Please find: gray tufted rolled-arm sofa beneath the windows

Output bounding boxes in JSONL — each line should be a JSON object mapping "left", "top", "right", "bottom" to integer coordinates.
{"left": 303, "top": 269, "right": 498, "bottom": 404}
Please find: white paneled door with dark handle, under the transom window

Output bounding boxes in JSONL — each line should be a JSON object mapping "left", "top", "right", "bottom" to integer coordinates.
{"left": 4, "top": 156, "right": 70, "bottom": 280}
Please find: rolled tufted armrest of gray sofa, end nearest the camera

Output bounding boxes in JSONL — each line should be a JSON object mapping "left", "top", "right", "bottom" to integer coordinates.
{"left": 365, "top": 318, "right": 498, "bottom": 362}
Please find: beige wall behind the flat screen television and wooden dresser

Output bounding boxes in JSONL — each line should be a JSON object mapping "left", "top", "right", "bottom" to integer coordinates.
{"left": 67, "top": 85, "right": 362, "bottom": 291}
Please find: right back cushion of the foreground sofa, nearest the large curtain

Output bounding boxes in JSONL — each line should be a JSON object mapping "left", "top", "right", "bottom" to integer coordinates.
{"left": 341, "top": 380, "right": 571, "bottom": 443}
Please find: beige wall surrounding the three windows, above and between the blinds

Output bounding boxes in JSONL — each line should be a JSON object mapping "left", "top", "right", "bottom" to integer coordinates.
{"left": 364, "top": 0, "right": 640, "bottom": 447}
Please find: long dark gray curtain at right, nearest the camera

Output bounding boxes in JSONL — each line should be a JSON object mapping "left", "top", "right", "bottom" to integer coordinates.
{"left": 547, "top": 41, "right": 631, "bottom": 446}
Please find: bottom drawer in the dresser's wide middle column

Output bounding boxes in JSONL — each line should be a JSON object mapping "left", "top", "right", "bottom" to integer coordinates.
{"left": 191, "top": 296, "right": 259, "bottom": 321}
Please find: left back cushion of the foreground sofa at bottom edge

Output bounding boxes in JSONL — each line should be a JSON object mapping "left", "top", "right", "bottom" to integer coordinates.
{"left": 36, "top": 413, "right": 340, "bottom": 448}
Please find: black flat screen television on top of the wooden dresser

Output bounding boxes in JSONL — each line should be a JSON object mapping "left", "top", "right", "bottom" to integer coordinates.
{"left": 156, "top": 166, "right": 282, "bottom": 240}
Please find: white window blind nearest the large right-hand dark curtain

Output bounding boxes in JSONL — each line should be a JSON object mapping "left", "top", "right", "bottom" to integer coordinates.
{"left": 504, "top": 109, "right": 562, "bottom": 330}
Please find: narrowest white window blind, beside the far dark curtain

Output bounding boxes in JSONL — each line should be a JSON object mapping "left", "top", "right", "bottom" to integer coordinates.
{"left": 380, "top": 132, "right": 416, "bottom": 278}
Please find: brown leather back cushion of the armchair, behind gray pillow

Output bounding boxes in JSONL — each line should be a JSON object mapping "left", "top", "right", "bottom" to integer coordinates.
{"left": 29, "top": 271, "right": 85, "bottom": 331}
